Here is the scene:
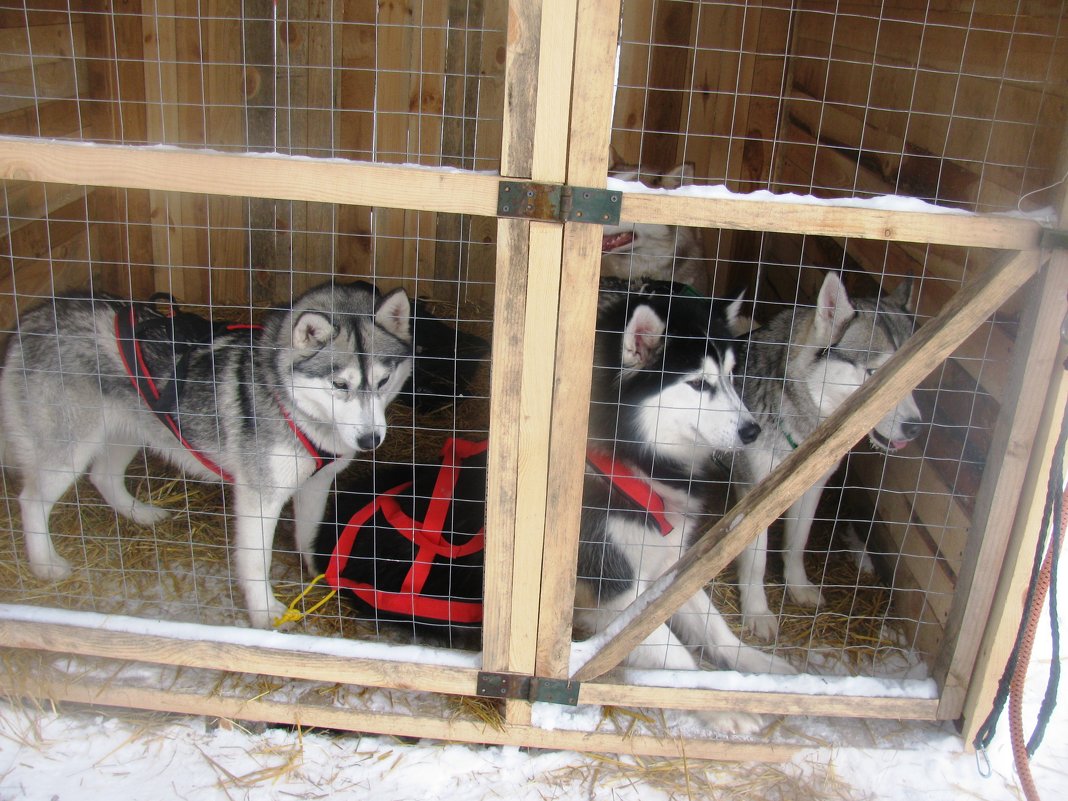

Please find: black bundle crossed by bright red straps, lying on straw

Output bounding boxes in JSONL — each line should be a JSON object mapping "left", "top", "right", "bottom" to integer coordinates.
{"left": 316, "top": 439, "right": 487, "bottom": 626}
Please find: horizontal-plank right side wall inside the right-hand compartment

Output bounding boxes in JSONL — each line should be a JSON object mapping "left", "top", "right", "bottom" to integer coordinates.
{"left": 761, "top": 0, "right": 1068, "bottom": 653}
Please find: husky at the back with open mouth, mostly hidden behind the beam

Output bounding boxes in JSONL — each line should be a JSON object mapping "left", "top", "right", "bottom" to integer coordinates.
{"left": 601, "top": 164, "right": 709, "bottom": 295}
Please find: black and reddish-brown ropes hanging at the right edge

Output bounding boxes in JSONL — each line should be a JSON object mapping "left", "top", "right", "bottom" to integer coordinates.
{"left": 973, "top": 375, "right": 1068, "bottom": 801}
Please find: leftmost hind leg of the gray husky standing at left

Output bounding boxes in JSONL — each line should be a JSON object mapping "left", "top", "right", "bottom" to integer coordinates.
{"left": 18, "top": 441, "right": 100, "bottom": 581}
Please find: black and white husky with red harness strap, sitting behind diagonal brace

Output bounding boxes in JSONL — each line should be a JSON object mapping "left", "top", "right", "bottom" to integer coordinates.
{"left": 576, "top": 286, "right": 794, "bottom": 728}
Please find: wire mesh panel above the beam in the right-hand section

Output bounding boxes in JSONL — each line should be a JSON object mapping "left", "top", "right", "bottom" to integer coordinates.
{"left": 613, "top": 0, "right": 1066, "bottom": 211}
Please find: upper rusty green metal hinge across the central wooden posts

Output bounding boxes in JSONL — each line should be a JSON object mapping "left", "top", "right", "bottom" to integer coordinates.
{"left": 497, "top": 180, "right": 623, "bottom": 225}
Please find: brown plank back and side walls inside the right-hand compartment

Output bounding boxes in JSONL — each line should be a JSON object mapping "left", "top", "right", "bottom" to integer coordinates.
{"left": 612, "top": 0, "right": 1068, "bottom": 653}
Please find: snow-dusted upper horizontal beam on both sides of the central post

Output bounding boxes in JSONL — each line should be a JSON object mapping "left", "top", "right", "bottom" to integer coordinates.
{"left": 0, "top": 137, "right": 1041, "bottom": 250}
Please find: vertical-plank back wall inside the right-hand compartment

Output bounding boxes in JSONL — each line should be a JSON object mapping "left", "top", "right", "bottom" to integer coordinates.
{"left": 612, "top": 0, "right": 790, "bottom": 292}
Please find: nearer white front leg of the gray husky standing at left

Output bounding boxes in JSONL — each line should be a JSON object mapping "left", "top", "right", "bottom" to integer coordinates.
{"left": 234, "top": 485, "right": 288, "bottom": 629}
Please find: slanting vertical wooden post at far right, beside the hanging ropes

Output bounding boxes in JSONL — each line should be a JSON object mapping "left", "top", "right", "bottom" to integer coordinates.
{"left": 935, "top": 138, "right": 1068, "bottom": 726}
